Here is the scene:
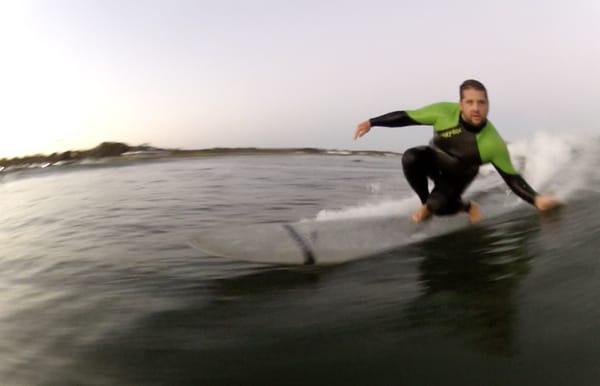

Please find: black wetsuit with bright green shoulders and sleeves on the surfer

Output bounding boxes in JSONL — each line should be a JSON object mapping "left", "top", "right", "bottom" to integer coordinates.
{"left": 369, "top": 102, "right": 537, "bottom": 215}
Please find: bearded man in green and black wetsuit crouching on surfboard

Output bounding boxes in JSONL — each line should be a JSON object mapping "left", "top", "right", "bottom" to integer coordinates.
{"left": 354, "top": 79, "right": 560, "bottom": 223}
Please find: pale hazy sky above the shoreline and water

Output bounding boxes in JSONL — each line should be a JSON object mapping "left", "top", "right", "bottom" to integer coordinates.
{"left": 0, "top": 0, "right": 600, "bottom": 158}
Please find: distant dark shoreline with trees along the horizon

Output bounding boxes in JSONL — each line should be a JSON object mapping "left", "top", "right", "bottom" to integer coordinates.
{"left": 0, "top": 142, "right": 401, "bottom": 172}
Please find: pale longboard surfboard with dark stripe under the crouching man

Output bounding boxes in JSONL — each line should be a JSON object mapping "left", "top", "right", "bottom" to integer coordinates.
{"left": 188, "top": 215, "right": 470, "bottom": 265}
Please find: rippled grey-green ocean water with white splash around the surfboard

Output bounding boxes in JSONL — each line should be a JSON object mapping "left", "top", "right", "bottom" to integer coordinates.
{"left": 0, "top": 136, "right": 600, "bottom": 385}
